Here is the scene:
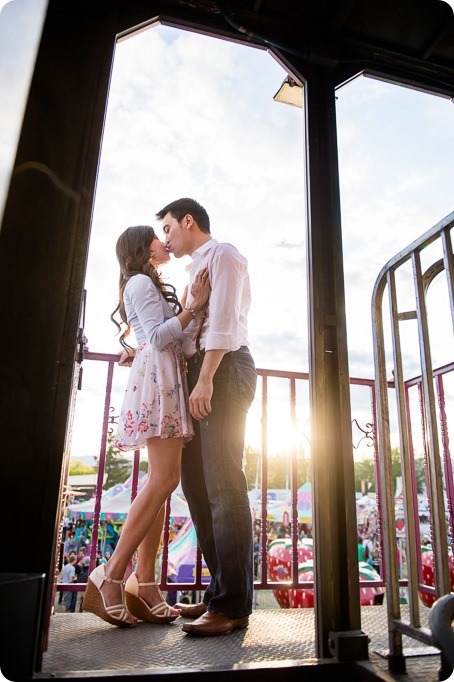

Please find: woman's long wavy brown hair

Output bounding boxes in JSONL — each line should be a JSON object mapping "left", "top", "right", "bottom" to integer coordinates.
{"left": 110, "top": 225, "right": 182, "bottom": 350}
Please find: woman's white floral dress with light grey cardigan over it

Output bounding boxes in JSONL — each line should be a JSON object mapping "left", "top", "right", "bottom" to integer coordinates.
{"left": 114, "top": 275, "right": 194, "bottom": 450}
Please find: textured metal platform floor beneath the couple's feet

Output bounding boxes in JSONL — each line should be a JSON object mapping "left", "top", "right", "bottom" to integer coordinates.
{"left": 39, "top": 593, "right": 440, "bottom": 682}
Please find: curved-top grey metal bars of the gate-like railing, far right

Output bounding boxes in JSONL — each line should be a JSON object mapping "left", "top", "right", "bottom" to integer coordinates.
{"left": 372, "top": 219, "right": 454, "bottom": 669}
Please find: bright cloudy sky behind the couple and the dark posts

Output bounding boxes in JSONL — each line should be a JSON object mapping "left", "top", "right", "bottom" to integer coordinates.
{"left": 0, "top": 0, "right": 454, "bottom": 459}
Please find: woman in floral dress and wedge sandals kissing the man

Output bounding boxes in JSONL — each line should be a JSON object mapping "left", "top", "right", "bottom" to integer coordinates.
{"left": 84, "top": 225, "right": 209, "bottom": 626}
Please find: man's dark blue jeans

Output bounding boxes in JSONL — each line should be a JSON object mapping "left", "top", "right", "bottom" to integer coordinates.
{"left": 181, "top": 347, "right": 257, "bottom": 618}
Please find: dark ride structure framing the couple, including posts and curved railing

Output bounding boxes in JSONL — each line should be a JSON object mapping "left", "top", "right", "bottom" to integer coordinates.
{"left": 0, "top": 0, "right": 454, "bottom": 682}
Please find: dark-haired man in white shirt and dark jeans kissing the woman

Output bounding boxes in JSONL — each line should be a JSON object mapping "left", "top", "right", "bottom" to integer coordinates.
{"left": 157, "top": 199, "right": 257, "bottom": 636}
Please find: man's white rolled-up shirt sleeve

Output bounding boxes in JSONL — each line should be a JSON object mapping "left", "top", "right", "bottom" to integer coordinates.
{"left": 205, "top": 248, "right": 247, "bottom": 350}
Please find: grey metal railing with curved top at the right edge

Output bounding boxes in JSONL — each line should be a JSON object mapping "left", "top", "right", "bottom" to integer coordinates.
{"left": 372, "top": 212, "right": 454, "bottom": 671}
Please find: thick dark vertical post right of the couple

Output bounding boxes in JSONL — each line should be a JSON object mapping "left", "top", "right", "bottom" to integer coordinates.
{"left": 303, "top": 65, "right": 361, "bottom": 657}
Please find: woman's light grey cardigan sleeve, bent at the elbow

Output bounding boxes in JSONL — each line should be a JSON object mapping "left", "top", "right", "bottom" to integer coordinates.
{"left": 127, "top": 275, "right": 183, "bottom": 350}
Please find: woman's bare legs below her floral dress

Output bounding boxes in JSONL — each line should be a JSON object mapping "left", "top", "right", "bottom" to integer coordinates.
{"left": 96, "top": 438, "right": 183, "bottom": 613}
